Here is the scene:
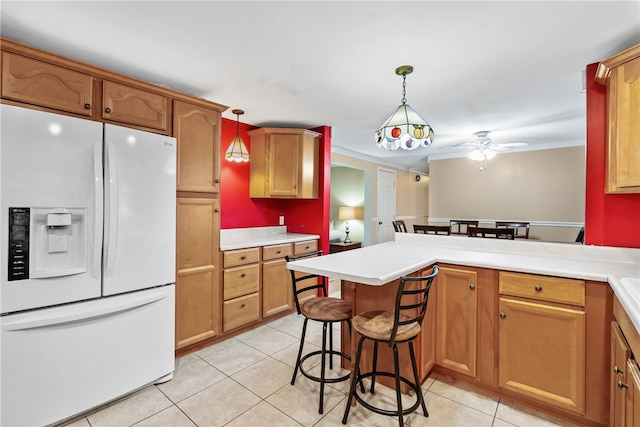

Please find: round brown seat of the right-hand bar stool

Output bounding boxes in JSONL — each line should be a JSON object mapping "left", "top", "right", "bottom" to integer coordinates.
{"left": 353, "top": 311, "right": 421, "bottom": 342}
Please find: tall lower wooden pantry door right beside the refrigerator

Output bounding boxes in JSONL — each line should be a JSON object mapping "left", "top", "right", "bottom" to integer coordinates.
{"left": 176, "top": 198, "right": 221, "bottom": 349}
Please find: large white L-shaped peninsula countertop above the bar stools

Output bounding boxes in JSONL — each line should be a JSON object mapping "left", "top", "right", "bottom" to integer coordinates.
{"left": 287, "top": 233, "right": 640, "bottom": 332}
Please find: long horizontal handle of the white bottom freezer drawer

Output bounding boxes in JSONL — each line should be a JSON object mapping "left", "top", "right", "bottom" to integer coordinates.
{"left": 2, "top": 289, "right": 169, "bottom": 331}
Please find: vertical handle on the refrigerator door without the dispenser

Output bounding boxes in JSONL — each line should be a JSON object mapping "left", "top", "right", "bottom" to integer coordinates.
{"left": 104, "top": 141, "right": 118, "bottom": 277}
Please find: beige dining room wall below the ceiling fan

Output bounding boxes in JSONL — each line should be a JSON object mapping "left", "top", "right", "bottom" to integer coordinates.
{"left": 429, "top": 147, "right": 585, "bottom": 242}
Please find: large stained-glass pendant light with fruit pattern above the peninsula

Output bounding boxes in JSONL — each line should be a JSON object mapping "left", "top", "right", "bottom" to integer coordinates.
{"left": 375, "top": 65, "right": 433, "bottom": 150}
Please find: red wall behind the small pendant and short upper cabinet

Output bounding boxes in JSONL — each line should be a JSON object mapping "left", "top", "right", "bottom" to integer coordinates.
{"left": 220, "top": 118, "right": 331, "bottom": 253}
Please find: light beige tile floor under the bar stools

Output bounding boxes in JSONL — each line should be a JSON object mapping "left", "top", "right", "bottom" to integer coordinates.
{"left": 68, "top": 314, "right": 570, "bottom": 427}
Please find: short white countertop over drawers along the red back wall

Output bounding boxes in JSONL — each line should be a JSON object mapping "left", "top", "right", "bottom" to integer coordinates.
{"left": 220, "top": 225, "right": 320, "bottom": 251}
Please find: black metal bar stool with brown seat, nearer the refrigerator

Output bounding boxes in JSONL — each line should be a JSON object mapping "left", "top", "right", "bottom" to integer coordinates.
{"left": 285, "top": 251, "right": 352, "bottom": 414}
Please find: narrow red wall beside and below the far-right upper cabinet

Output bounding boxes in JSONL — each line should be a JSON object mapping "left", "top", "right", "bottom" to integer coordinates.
{"left": 585, "top": 63, "right": 640, "bottom": 248}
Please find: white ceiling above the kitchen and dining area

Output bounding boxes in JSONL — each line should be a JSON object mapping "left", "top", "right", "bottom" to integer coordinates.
{"left": 0, "top": 0, "right": 640, "bottom": 171}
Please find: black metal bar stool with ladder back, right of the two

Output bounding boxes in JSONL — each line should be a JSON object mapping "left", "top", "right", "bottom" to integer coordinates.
{"left": 342, "top": 266, "right": 438, "bottom": 427}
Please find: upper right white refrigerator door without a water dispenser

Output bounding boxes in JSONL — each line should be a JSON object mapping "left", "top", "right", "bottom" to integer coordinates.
{"left": 102, "top": 125, "right": 176, "bottom": 295}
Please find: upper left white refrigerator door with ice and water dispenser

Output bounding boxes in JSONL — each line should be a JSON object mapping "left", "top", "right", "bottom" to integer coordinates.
{"left": 0, "top": 104, "right": 102, "bottom": 313}
